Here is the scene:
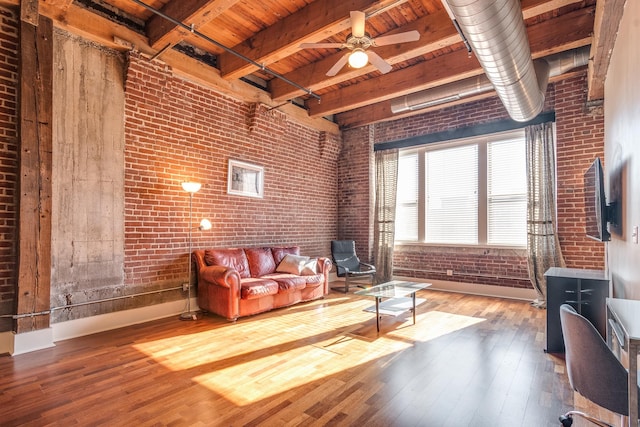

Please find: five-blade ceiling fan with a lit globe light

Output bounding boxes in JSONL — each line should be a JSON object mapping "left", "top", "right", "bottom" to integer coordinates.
{"left": 300, "top": 11, "right": 420, "bottom": 76}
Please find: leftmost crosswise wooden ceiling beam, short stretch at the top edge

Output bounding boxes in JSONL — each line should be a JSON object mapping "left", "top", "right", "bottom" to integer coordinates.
{"left": 146, "top": 0, "right": 240, "bottom": 49}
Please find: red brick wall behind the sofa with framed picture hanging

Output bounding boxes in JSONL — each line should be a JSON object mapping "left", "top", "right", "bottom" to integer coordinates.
{"left": 125, "top": 54, "right": 339, "bottom": 285}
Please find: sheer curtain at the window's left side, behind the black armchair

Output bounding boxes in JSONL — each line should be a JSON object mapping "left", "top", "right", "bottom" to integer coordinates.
{"left": 373, "top": 149, "right": 398, "bottom": 283}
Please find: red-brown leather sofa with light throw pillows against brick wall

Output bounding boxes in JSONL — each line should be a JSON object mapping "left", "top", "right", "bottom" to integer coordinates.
{"left": 192, "top": 246, "right": 331, "bottom": 320}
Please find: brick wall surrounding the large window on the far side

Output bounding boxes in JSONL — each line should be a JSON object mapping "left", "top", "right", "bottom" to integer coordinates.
{"left": 338, "top": 71, "right": 604, "bottom": 288}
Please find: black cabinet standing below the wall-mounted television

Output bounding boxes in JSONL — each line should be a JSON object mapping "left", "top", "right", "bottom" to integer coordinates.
{"left": 544, "top": 267, "right": 609, "bottom": 353}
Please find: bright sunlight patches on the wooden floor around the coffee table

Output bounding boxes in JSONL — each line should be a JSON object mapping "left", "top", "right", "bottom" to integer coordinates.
{"left": 135, "top": 299, "right": 484, "bottom": 406}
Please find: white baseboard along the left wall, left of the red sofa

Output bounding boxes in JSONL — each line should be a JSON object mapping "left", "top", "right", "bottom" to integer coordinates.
{"left": 0, "top": 299, "right": 198, "bottom": 356}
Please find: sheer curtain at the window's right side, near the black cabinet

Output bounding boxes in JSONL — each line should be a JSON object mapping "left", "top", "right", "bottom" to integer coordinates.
{"left": 525, "top": 123, "right": 565, "bottom": 308}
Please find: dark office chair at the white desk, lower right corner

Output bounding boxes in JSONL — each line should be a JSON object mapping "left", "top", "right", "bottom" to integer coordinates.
{"left": 560, "top": 304, "right": 629, "bottom": 427}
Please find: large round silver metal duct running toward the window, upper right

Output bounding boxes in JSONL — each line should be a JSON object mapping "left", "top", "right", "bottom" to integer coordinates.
{"left": 445, "top": 0, "right": 544, "bottom": 122}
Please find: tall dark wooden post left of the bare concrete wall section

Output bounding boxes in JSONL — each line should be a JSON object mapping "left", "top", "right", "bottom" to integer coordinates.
{"left": 14, "top": 0, "right": 53, "bottom": 333}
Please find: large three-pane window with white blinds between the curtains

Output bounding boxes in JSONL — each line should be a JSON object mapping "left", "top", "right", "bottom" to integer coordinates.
{"left": 396, "top": 130, "right": 527, "bottom": 247}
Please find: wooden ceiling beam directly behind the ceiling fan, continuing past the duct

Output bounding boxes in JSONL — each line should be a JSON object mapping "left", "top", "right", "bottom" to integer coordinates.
{"left": 270, "top": 0, "right": 580, "bottom": 101}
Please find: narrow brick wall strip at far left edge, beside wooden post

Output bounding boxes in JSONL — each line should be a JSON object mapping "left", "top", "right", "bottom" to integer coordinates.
{"left": 0, "top": 8, "right": 18, "bottom": 332}
